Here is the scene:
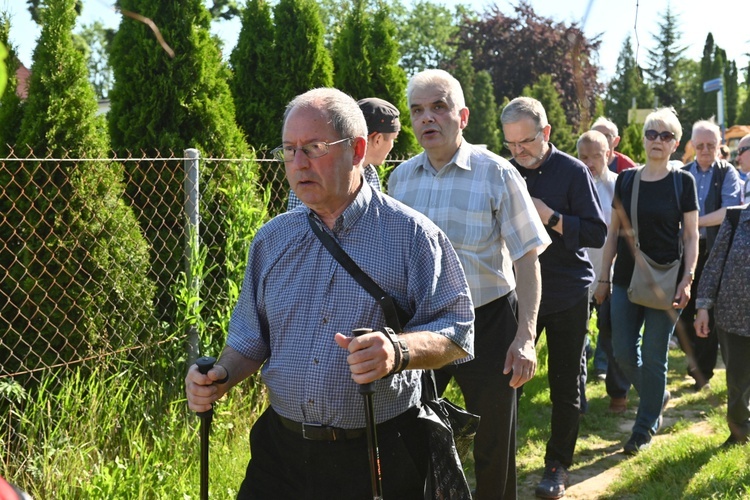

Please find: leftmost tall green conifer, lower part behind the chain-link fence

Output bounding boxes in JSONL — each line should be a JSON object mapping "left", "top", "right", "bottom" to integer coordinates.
{"left": 0, "top": 0, "right": 154, "bottom": 371}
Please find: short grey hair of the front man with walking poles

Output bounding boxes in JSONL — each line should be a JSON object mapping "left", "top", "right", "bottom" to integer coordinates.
{"left": 284, "top": 87, "right": 367, "bottom": 139}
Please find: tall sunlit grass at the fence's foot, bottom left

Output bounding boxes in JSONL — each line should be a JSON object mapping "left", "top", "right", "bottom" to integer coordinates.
{"left": 2, "top": 363, "right": 265, "bottom": 499}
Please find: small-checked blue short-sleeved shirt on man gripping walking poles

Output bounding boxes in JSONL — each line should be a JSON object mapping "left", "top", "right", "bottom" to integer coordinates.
{"left": 227, "top": 183, "right": 474, "bottom": 428}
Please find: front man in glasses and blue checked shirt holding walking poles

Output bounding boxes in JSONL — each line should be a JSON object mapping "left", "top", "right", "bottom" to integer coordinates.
{"left": 186, "top": 89, "right": 474, "bottom": 500}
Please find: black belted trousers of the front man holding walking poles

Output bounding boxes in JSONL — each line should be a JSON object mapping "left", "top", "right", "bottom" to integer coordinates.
{"left": 237, "top": 406, "right": 429, "bottom": 500}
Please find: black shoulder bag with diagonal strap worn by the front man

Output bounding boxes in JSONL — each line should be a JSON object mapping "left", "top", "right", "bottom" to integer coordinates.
{"left": 308, "top": 214, "right": 479, "bottom": 500}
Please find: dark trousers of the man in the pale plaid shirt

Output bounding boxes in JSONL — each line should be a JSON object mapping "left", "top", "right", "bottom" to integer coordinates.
{"left": 435, "top": 291, "right": 518, "bottom": 500}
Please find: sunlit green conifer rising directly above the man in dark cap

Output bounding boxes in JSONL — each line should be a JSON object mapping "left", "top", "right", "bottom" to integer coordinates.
{"left": 333, "top": 0, "right": 419, "bottom": 155}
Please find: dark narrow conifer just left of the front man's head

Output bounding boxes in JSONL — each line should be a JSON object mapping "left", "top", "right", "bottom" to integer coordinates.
{"left": 229, "top": 0, "right": 280, "bottom": 150}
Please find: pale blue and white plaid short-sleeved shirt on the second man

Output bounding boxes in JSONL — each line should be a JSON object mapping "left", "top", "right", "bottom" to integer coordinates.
{"left": 388, "top": 141, "right": 551, "bottom": 307}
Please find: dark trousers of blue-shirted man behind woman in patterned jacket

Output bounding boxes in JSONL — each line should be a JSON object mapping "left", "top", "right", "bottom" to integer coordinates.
{"left": 677, "top": 239, "right": 719, "bottom": 385}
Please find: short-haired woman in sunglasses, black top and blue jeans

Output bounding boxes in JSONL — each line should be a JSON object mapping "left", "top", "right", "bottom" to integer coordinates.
{"left": 595, "top": 108, "right": 698, "bottom": 455}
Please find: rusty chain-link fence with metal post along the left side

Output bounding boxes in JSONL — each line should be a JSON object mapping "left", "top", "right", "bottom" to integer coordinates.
{"left": 0, "top": 150, "right": 412, "bottom": 492}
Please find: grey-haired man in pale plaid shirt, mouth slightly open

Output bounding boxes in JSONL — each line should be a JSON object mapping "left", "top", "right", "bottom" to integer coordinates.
{"left": 388, "top": 70, "right": 550, "bottom": 500}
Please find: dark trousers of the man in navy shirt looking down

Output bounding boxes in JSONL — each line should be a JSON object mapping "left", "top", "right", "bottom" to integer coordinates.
{"left": 537, "top": 293, "right": 589, "bottom": 467}
